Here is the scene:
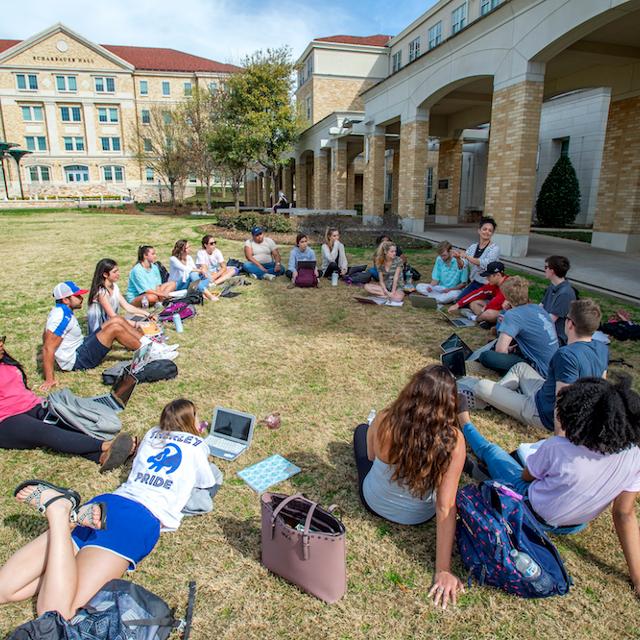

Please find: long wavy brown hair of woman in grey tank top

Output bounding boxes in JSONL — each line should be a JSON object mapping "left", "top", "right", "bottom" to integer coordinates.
{"left": 380, "top": 365, "right": 459, "bottom": 498}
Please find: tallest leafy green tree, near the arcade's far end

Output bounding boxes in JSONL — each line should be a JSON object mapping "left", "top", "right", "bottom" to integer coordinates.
{"left": 228, "top": 47, "right": 303, "bottom": 204}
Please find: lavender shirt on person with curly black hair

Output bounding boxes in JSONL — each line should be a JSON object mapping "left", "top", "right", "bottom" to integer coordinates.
{"left": 527, "top": 436, "right": 640, "bottom": 526}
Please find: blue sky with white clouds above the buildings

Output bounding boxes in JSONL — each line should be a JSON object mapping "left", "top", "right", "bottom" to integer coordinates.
{"left": 0, "top": 0, "right": 436, "bottom": 64}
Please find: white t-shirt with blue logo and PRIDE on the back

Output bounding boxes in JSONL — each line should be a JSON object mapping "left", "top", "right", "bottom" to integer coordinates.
{"left": 113, "top": 427, "right": 216, "bottom": 531}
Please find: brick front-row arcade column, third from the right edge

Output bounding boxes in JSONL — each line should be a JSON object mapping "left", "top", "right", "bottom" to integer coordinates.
{"left": 398, "top": 110, "right": 429, "bottom": 233}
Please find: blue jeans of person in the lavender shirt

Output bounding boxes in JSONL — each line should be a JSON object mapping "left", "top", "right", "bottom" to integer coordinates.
{"left": 462, "top": 422, "right": 587, "bottom": 535}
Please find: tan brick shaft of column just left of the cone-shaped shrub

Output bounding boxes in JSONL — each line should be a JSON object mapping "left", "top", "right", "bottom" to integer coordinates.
{"left": 484, "top": 80, "right": 544, "bottom": 235}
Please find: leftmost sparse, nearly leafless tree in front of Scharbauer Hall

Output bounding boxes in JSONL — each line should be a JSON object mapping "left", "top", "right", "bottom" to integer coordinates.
{"left": 132, "top": 106, "right": 189, "bottom": 208}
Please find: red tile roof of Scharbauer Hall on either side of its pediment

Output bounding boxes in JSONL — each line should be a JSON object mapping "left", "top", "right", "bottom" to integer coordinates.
{"left": 0, "top": 40, "right": 240, "bottom": 73}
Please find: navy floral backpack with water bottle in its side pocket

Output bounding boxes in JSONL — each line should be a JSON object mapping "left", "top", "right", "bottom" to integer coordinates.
{"left": 456, "top": 480, "right": 572, "bottom": 598}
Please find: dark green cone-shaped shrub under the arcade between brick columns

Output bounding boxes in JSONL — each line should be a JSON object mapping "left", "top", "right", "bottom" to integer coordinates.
{"left": 536, "top": 156, "right": 580, "bottom": 227}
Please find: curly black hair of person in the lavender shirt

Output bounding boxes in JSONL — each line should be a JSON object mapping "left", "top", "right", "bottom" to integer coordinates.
{"left": 556, "top": 375, "right": 640, "bottom": 453}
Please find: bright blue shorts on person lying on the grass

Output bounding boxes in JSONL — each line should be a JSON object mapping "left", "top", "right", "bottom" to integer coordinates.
{"left": 71, "top": 493, "right": 160, "bottom": 571}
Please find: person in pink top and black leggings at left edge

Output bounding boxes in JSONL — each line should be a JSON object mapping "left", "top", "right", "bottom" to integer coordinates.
{"left": 0, "top": 336, "right": 136, "bottom": 471}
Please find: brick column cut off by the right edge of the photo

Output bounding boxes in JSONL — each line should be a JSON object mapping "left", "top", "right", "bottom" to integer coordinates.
{"left": 591, "top": 96, "right": 640, "bottom": 252}
